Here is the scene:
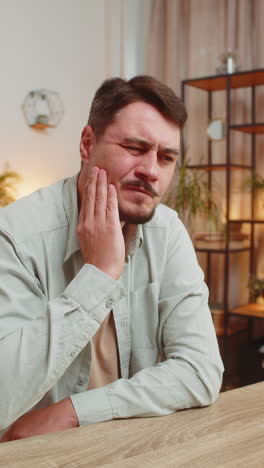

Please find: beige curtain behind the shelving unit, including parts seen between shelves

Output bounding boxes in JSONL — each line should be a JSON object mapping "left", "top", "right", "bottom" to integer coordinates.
{"left": 145, "top": 0, "right": 264, "bottom": 318}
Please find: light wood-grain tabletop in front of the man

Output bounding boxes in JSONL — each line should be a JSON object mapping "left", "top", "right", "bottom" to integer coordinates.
{"left": 0, "top": 382, "right": 264, "bottom": 468}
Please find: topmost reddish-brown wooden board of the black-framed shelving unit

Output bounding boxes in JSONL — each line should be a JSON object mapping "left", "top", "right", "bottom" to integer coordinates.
{"left": 183, "top": 69, "right": 264, "bottom": 91}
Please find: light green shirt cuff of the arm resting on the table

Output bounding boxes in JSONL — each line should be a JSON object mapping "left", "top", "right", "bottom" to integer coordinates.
{"left": 70, "top": 387, "right": 115, "bottom": 426}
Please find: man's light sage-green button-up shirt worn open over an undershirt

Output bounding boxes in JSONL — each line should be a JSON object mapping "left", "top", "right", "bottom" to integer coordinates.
{"left": 0, "top": 176, "right": 223, "bottom": 430}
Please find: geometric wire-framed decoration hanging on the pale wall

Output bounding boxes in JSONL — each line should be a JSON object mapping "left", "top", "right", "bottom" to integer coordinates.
{"left": 22, "top": 89, "right": 64, "bottom": 130}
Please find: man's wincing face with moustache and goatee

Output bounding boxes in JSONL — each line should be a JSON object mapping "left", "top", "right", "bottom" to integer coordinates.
{"left": 79, "top": 101, "right": 180, "bottom": 224}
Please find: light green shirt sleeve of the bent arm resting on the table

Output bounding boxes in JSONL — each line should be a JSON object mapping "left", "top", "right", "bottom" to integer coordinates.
{"left": 71, "top": 219, "right": 223, "bottom": 425}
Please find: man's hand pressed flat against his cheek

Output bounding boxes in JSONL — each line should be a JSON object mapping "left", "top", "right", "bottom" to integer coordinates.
{"left": 77, "top": 167, "right": 125, "bottom": 279}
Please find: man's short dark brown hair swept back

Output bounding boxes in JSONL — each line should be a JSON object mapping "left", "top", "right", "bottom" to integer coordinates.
{"left": 88, "top": 75, "right": 187, "bottom": 137}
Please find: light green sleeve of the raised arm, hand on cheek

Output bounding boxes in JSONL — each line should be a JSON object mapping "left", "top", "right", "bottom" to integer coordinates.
{"left": 0, "top": 232, "right": 124, "bottom": 430}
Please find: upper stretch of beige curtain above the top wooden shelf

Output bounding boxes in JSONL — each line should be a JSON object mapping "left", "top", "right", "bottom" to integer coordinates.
{"left": 146, "top": 0, "right": 264, "bottom": 93}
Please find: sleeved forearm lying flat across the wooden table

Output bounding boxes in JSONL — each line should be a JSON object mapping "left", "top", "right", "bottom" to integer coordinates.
{"left": 71, "top": 348, "right": 222, "bottom": 425}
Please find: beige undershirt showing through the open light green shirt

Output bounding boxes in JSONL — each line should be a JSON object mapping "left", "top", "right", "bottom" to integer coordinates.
{"left": 87, "top": 225, "right": 138, "bottom": 390}
